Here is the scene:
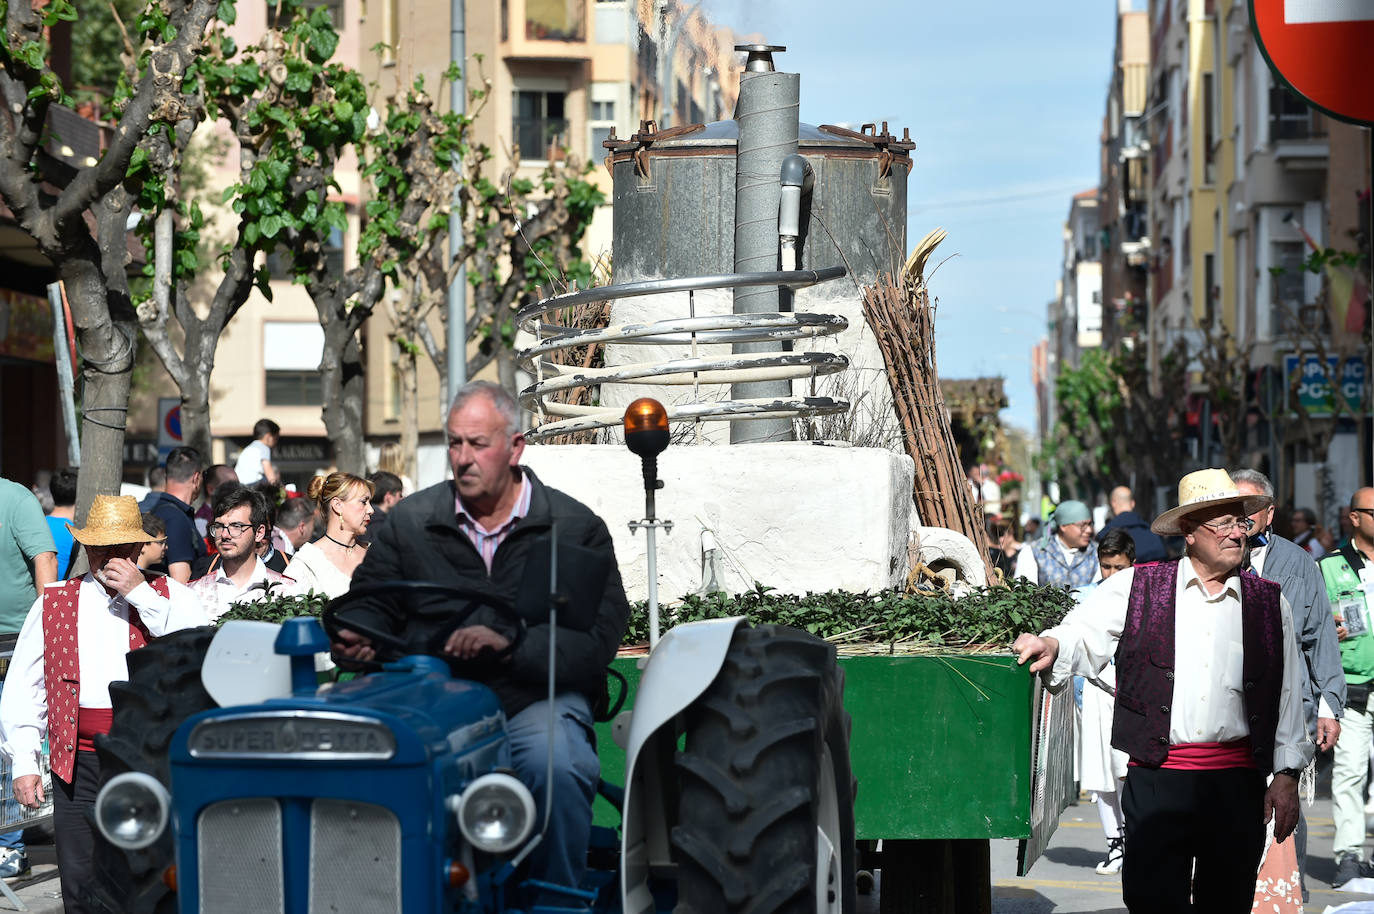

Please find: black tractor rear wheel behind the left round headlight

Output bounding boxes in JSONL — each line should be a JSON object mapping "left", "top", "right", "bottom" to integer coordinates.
{"left": 91, "top": 625, "right": 218, "bottom": 914}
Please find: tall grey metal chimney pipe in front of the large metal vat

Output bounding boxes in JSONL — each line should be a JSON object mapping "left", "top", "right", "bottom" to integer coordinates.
{"left": 730, "top": 45, "right": 801, "bottom": 444}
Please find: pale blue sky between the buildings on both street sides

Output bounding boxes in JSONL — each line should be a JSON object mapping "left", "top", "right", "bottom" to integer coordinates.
{"left": 702, "top": 0, "right": 1117, "bottom": 429}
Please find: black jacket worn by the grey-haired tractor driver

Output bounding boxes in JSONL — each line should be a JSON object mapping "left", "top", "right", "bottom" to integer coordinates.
{"left": 345, "top": 469, "right": 629, "bottom": 716}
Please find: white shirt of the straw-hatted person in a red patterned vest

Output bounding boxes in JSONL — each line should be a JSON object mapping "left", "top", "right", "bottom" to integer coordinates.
{"left": 0, "top": 572, "right": 209, "bottom": 778}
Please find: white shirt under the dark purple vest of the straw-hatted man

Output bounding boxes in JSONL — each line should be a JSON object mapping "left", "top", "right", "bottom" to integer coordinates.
{"left": 1044, "top": 558, "right": 1315, "bottom": 771}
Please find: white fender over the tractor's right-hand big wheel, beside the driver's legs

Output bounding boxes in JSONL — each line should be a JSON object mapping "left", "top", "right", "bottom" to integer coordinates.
{"left": 620, "top": 616, "right": 745, "bottom": 914}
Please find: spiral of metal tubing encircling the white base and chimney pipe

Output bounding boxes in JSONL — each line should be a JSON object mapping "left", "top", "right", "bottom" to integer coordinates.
{"left": 517, "top": 267, "right": 849, "bottom": 441}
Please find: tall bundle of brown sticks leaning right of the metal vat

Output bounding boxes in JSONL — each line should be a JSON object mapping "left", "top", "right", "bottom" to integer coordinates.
{"left": 863, "top": 230, "right": 995, "bottom": 580}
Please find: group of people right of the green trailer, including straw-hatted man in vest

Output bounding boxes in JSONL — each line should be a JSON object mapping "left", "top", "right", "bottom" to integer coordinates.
{"left": 1011, "top": 469, "right": 1374, "bottom": 911}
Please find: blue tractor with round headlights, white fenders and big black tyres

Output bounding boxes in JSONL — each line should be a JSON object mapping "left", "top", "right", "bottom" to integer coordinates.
{"left": 85, "top": 584, "right": 855, "bottom": 914}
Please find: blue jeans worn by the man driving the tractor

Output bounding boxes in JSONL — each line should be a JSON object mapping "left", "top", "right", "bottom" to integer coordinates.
{"left": 506, "top": 693, "right": 600, "bottom": 888}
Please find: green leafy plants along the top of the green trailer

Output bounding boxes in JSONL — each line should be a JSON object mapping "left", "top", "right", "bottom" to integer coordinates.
{"left": 220, "top": 580, "right": 1073, "bottom": 653}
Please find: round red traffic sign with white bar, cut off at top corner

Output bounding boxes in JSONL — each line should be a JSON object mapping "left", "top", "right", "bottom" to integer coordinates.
{"left": 1249, "top": 0, "right": 1374, "bottom": 124}
